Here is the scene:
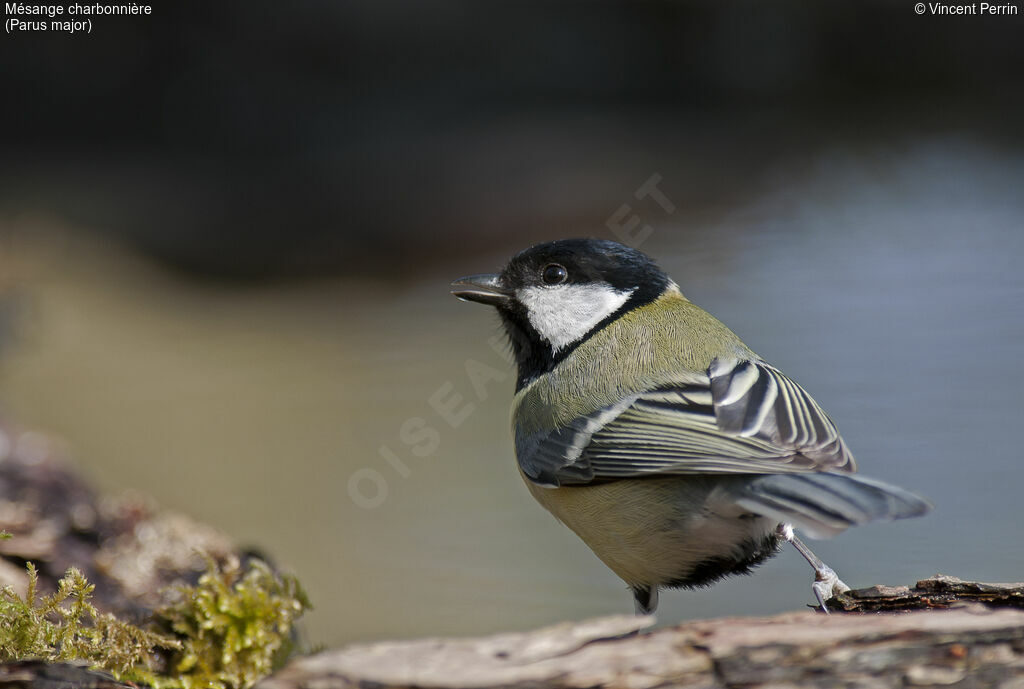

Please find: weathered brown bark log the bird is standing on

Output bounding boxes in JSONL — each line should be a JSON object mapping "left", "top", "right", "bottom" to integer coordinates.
{"left": 257, "top": 577, "right": 1024, "bottom": 689}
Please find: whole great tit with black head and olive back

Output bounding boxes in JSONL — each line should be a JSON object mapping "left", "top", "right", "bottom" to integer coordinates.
{"left": 452, "top": 240, "right": 931, "bottom": 614}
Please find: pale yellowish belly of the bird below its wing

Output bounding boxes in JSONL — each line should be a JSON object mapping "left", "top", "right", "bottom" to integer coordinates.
{"left": 524, "top": 476, "right": 778, "bottom": 587}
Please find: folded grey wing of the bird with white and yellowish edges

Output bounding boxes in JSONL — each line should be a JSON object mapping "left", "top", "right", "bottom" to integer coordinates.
{"left": 516, "top": 359, "right": 854, "bottom": 486}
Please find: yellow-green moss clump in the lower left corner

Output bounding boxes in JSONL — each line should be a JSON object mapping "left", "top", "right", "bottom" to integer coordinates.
{"left": 0, "top": 560, "right": 310, "bottom": 689}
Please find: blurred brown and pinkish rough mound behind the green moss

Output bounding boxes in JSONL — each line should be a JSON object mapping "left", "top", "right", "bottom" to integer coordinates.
{"left": 0, "top": 421, "right": 239, "bottom": 619}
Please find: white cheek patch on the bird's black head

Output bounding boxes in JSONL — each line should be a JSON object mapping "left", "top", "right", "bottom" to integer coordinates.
{"left": 516, "top": 285, "right": 634, "bottom": 352}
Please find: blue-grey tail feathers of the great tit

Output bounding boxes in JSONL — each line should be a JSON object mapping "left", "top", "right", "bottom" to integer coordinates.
{"left": 736, "top": 472, "right": 932, "bottom": 539}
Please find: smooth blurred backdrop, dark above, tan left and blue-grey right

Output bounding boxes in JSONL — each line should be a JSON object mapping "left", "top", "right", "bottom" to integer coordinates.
{"left": 0, "top": 0, "right": 1024, "bottom": 645}
